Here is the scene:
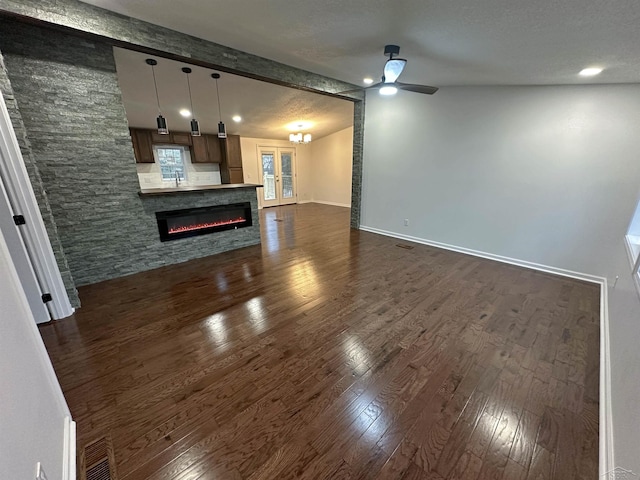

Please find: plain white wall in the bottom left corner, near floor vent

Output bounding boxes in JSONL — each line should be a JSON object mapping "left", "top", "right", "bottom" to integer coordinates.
{"left": 0, "top": 227, "right": 69, "bottom": 480}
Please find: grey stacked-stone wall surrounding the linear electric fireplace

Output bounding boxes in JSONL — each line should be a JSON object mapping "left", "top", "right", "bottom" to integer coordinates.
{"left": 0, "top": 18, "right": 260, "bottom": 288}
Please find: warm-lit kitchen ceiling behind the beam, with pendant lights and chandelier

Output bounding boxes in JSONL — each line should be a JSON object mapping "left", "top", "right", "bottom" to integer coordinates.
{"left": 114, "top": 48, "right": 353, "bottom": 140}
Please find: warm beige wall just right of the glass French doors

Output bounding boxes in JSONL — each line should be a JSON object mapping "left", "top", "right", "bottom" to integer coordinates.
{"left": 310, "top": 127, "right": 353, "bottom": 207}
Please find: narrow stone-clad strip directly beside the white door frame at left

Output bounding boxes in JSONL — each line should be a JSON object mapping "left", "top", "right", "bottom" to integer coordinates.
{"left": 0, "top": 47, "right": 80, "bottom": 308}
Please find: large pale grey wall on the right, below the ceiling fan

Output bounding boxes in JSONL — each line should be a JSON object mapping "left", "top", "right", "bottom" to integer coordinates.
{"left": 361, "top": 85, "right": 640, "bottom": 472}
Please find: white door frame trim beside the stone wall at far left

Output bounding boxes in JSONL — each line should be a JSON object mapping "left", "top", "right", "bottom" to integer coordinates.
{"left": 0, "top": 95, "right": 74, "bottom": 320}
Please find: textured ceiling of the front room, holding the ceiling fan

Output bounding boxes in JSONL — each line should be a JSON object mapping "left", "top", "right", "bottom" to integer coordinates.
{"left": 87, "top": 0, "right": 640, "bottom": 86}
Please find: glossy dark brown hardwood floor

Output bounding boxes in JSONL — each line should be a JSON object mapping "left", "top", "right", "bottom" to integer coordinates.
{"left": 40, "top": 204, "right": 599, "bottom": 480}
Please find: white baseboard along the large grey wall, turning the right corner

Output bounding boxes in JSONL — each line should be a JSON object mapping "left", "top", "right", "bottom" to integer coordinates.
{"left": 360, "top": 225, "right": 615, "bottom": 476}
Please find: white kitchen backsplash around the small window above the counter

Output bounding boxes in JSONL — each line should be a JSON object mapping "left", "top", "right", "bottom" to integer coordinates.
{"left": 136, "top": 145, "right": 222, "bottom": 189}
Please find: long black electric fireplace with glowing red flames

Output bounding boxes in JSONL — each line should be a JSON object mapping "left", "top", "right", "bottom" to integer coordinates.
{"left": 156, "top": 202, "right": 252, "bottom": 242}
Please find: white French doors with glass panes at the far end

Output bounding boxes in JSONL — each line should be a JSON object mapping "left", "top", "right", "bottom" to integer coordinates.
{"left": 258, "top": 147, "right": 297, "bottom": 207}
